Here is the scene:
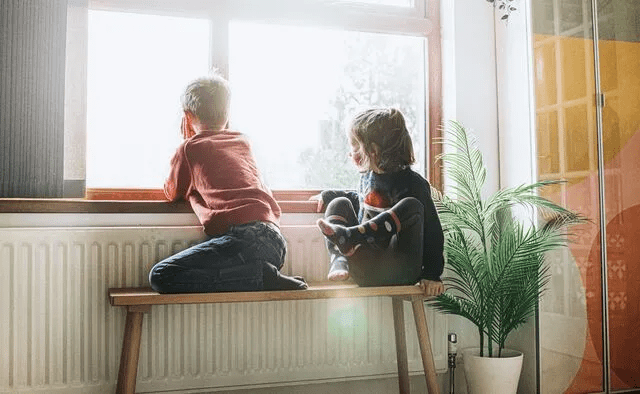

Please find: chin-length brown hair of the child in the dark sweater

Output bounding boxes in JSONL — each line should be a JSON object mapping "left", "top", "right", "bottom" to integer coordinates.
{"left": 349, "top": 108, "right": 416, "bottom": 172}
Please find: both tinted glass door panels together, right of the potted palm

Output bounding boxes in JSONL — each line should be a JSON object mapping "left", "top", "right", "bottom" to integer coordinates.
{"left": 532, "top": 0, "right": 640, "bottom": 393}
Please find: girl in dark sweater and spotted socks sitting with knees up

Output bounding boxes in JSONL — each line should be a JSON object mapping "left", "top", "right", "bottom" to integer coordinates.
{"left": 317, "top": 108, "right": 444, "bottom": 296}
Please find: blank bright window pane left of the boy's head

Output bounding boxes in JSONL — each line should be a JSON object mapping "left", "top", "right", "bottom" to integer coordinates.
{"left": 87, "top": 11, "right": 209, "bottom": 188}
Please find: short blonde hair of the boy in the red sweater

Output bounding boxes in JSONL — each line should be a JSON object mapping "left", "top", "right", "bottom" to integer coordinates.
{"left": 181, "top": 71, "right": 231, "bottom": 127}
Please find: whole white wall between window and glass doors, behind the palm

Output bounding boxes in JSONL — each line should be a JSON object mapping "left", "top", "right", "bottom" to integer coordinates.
{"left": 442, "top": 0, "right": 536, "bottom": 393}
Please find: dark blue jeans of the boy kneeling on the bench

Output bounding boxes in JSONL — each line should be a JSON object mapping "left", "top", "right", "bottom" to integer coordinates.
{"left": 149, "top": 222, "right": 287, "bottom": 293}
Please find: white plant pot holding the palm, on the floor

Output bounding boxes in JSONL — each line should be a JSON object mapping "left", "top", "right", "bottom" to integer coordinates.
{"left": 462, "top": 348, "right": 522, "bottom": 394}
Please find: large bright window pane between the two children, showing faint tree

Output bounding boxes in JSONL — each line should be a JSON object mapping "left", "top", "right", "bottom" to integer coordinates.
{"left": 229, "top": 22, "right": 426, "bottom": 189}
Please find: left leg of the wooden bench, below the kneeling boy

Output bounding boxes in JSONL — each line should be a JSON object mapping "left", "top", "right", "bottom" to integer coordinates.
{"left": 116, "top": 305, "right": 151, "bottom": 394}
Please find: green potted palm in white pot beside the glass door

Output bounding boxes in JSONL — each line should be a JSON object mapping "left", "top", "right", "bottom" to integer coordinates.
{"left": 433, "top": 121, "right": 585, "bottom": 393}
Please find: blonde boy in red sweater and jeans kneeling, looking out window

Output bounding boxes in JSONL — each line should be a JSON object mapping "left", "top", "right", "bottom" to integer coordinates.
{"left": 149, "top": 74, "right": 307, "bottom": 293}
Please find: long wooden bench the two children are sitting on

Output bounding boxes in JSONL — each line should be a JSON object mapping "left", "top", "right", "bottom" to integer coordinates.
{"left": 109, "top": 284, "right": 439, "bottom": 394}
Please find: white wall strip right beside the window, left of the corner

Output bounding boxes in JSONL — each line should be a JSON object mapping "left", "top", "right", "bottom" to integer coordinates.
{"left": 441, "top": 0, "right": 499, "bottom": 393}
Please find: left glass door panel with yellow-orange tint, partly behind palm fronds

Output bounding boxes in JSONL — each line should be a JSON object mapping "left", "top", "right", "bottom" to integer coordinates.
{"left": 532, "top": 0, "right": 604, "bottom": 393}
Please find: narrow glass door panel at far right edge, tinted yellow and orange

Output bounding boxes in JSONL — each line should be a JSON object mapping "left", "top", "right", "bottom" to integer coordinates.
{"left": 597, "top": 0, "right": 640, "bottom": 391}
